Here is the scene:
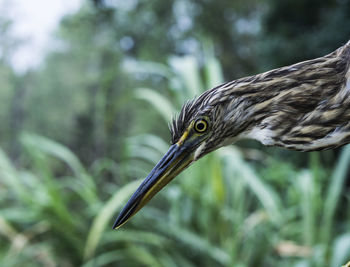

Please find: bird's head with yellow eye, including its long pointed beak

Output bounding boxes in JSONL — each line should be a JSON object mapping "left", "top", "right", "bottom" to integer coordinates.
{"left": 113, "top": 88, "right": 234, "bottom": 229}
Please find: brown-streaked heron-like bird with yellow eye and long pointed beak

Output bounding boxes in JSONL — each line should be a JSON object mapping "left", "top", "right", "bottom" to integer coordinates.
{"left": 113, "top": 40, "right": 350, "bottom": 229}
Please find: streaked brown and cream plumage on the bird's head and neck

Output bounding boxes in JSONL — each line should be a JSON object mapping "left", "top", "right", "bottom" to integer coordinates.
{"left": 170, "top": 41, "right": 350, "bottom": 156}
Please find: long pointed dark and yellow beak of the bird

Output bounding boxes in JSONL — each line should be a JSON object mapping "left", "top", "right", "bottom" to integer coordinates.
{"left": 113, "top": 143, "right": 193, "bottom": 229}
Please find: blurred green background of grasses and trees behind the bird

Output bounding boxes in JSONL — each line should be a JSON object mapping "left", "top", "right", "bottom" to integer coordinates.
{"left": 0, "top": 0, "right": 350, "bottom": 267}
